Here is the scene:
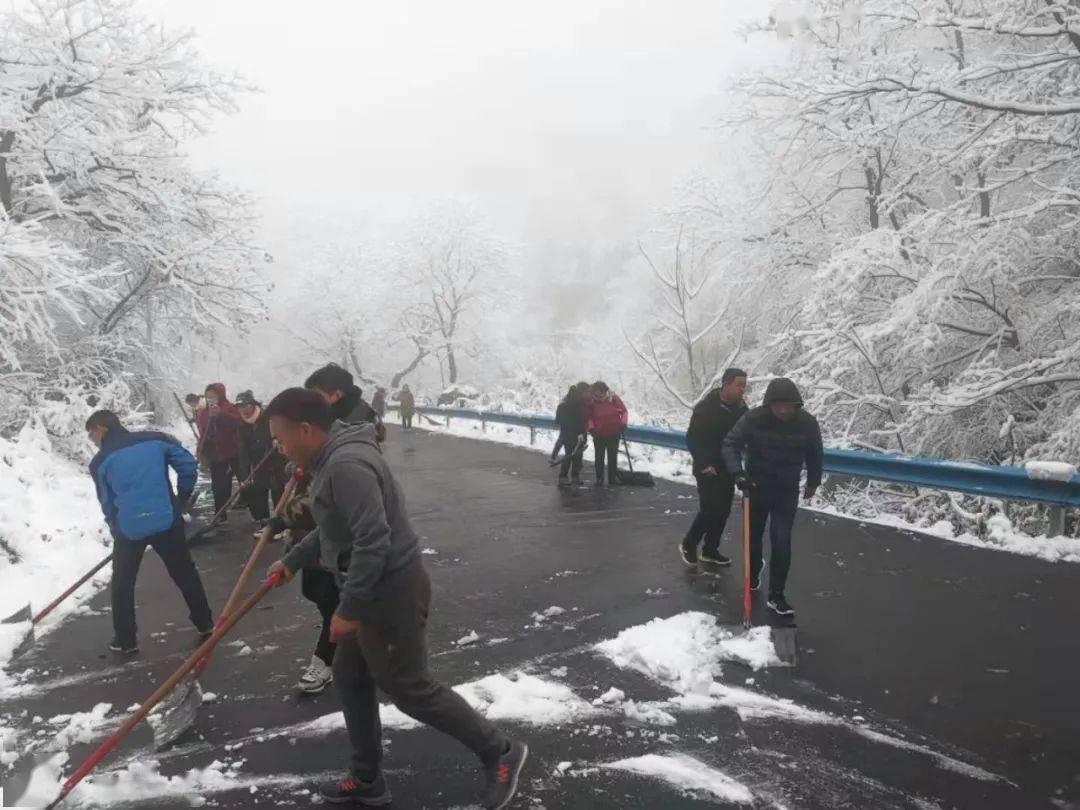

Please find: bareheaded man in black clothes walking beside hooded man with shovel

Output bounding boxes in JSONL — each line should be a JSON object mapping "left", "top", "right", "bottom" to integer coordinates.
{"left": 679, "top": 368, "right": 746, "bottom": 565}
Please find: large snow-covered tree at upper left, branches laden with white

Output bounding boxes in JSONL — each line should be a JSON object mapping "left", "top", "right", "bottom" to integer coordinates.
{"left": 0, "top": 0, "right": 264, "bottom": 438}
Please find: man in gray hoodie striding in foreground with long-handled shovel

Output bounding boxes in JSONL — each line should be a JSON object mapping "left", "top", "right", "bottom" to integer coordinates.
{"left": 267, "top": 388, "right": 528, "bottom": 808}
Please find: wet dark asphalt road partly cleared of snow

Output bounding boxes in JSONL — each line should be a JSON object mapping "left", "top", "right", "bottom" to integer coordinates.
{"left": 0, "top": 431, "right": 1080, "bottom": 808}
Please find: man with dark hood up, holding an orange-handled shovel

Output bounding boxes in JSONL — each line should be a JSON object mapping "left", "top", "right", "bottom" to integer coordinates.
{"left": 724, "top": 377, "right": 824, "bottom": 616}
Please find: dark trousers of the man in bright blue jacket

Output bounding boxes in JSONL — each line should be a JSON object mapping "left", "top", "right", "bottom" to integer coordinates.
{"left": 112, "top": 521, "right": 214, "bottom": 646}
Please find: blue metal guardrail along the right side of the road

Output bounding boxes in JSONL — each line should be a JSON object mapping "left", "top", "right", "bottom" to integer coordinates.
{"left": 401, "top": 406, "right": 1080, "bottom": 508}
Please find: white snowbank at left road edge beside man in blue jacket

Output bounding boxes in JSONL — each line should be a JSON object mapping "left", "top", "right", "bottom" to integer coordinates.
{"left": 0, "top": 426, "right": 111, "bottom": 666}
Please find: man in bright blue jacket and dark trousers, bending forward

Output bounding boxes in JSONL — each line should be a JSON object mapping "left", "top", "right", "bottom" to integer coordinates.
{"left": 86, "top": 410, "right": 214, "bottom": 656}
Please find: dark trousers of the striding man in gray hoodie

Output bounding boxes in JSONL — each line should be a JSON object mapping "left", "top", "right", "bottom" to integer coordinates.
{"left": 334, "top": 561, "right": 508, "bottom": 781}
